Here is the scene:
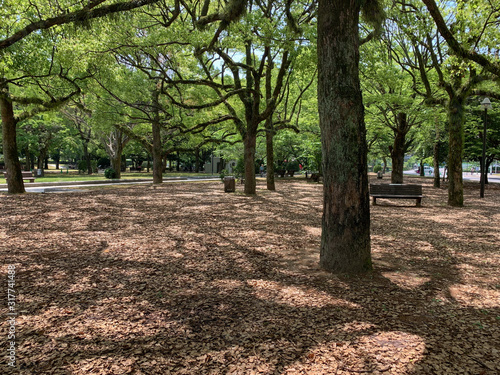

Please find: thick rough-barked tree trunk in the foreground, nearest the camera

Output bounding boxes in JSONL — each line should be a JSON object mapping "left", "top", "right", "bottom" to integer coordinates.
{"left": 318, "top": 0, "right": 372, "bottom": 273}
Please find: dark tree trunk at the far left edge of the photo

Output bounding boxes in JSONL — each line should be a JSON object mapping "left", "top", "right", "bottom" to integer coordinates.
{"left": 0, "top": 96, "right": 26, "bottom": 194}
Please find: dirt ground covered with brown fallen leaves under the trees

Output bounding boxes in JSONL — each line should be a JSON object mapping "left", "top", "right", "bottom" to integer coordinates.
{"left": 0, "top": 178, "right": 500, "bottom": 375}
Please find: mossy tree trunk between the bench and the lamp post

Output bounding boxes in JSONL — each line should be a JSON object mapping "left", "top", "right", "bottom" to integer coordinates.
{"left": 448, "top": 96, "right": 465, "bottom": 207}
